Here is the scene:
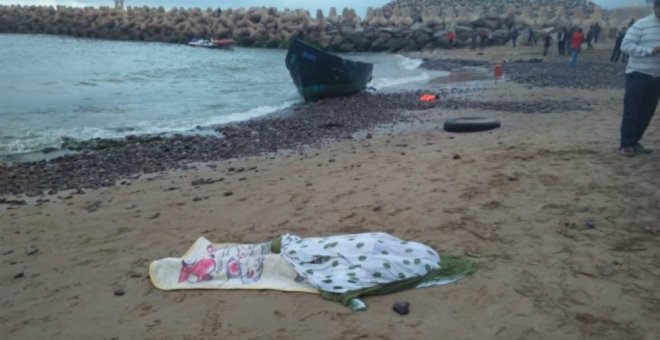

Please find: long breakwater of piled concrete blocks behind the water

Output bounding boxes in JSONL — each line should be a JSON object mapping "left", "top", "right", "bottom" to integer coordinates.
{"left": 0, "top": 0, "right": 622, "bottom": 52}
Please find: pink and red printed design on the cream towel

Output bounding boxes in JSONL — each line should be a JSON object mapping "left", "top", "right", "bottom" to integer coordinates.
{"left": 179, "top": 243, "right": 270, "bottom": 284}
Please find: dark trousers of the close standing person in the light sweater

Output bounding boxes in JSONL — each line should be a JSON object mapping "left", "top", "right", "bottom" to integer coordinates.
{"left": 621, "top": 72, "right": 660, "bottom": 147}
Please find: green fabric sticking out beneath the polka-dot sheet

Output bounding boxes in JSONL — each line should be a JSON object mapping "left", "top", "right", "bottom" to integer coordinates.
{"left": 321, "top": 255, "right": 475, "bottom": 306}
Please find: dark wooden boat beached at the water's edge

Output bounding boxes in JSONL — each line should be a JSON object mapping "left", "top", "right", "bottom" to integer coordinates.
{"left": 285, "top": 39, "right": 373, "bottom": 101}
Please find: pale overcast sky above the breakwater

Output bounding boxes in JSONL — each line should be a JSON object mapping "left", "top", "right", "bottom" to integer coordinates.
{"left": 0, "top": 0, "right": 645, "bottom": 16}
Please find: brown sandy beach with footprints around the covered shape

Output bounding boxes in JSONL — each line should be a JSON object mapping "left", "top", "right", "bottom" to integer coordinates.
{"left": 0, "top": 47, "right": 660, "bottom": 339}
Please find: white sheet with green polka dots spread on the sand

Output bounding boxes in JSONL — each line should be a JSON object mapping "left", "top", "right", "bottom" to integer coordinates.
{"left": 280, "top": 233, "right": 440, "bottom": 293}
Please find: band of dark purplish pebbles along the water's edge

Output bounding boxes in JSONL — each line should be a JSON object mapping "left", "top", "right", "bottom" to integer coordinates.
{"left": 0, "top": 48, "right": 621, "bottom": 197}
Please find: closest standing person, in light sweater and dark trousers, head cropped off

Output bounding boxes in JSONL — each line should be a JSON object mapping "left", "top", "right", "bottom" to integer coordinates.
{"left": 619, "top": 0, "right": 660, "bottom": 157}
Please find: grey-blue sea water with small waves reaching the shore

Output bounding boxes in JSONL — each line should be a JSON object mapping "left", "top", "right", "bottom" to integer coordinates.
{"left": 0, "top": 34, "right": 447, "bottom": 161}
